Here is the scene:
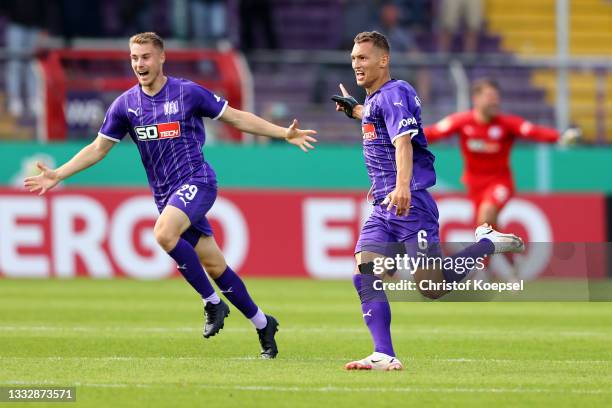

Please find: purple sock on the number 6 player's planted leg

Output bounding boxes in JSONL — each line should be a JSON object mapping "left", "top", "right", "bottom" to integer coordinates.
{"left": 353, "top": 274, "right": 395, "bottom": 357}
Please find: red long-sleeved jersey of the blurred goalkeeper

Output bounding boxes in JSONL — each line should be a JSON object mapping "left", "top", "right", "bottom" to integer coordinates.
{"left": 425, "top": 111, "right": 559, "bottom": 184}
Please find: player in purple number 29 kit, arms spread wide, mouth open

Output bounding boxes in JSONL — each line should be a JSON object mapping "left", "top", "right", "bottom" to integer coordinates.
{"left": 24, "top": 32, "right": 316, "bottom": 359}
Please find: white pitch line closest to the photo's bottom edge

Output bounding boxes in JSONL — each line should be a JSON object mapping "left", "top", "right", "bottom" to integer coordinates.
{"left": 0, "top": 380, "right": 612, "bottom": 395}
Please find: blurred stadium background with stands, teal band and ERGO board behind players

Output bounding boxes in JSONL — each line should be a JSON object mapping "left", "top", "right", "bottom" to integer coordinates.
{"left": 0, "top": 0, "right": 612, "bottom": 278}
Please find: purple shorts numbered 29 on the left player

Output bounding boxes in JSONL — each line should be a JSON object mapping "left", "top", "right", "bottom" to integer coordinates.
{"left": 167, "top": 181, "right": 217, "bottom": 247}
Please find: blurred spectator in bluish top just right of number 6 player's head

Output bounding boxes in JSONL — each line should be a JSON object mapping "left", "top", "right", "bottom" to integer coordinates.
{"left": 376, "top": 3, "right": 431, "bottom": 101}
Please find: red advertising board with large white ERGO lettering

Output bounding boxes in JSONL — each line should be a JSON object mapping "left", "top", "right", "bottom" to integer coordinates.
{"left": 0, "top": 188, "right": 606, "bottom": 279}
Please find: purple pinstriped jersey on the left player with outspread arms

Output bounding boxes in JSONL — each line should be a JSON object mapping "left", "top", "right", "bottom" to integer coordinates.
{"left": 98, "top": 77, "right": 227, "bottom": 208}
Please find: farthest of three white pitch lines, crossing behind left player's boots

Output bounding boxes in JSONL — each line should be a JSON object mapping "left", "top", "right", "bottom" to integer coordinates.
{"left": 0, "top": 325, "right": 612, "bottom": 339}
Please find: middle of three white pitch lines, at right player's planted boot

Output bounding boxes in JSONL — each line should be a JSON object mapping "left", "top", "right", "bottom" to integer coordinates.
{"left": 0, "top": 356, "right": 612, "bottom": 365}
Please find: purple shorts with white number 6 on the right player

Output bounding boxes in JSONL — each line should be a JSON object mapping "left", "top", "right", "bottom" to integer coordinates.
{"left": 355, "top": 190, "right": 440, "bottom": 256}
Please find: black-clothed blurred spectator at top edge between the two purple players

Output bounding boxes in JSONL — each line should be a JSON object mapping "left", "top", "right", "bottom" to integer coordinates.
{"left": 239, "top": 0, "right": 278, "bottom": 52}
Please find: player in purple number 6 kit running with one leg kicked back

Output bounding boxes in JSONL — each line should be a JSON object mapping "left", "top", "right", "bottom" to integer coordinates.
{"left": 332, "top": 31, "right": 524, "bottom": 371}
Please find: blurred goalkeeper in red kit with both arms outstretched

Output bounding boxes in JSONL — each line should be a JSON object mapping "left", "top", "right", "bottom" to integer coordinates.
{"left": 424, "top": 79, "right": 580, "bottom": 228}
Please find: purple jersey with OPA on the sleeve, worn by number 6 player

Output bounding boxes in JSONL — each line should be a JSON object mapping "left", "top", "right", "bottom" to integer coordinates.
{"left": 361, "top": 79, "right": 436, "bottom": 204}
